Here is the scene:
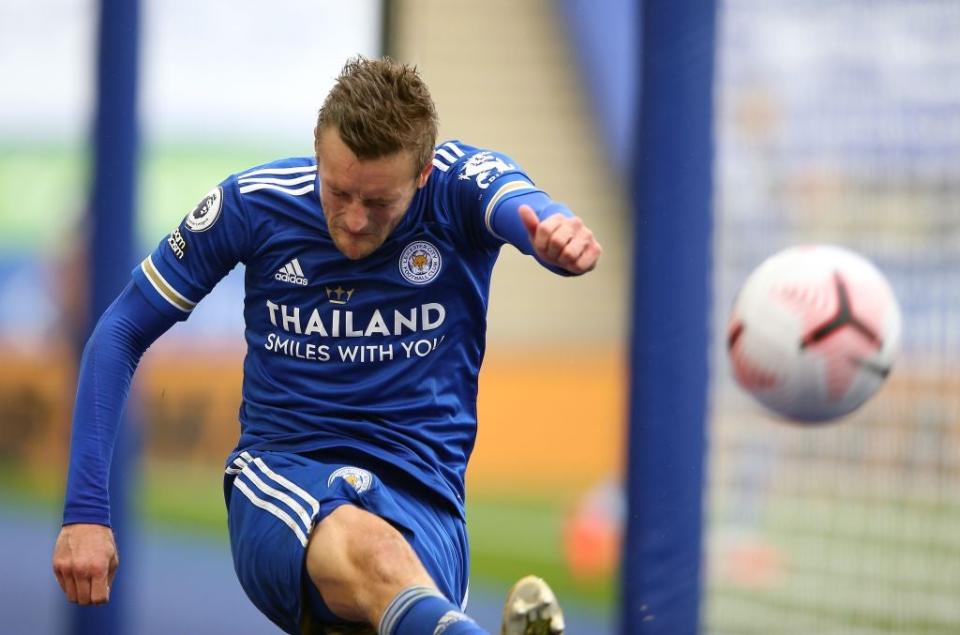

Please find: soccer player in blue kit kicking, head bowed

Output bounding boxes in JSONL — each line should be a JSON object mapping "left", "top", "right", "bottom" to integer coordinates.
{"left": 53, "top": 58, "right": 601, "bottom": 635}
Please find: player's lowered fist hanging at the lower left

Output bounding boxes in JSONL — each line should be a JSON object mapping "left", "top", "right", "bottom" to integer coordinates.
{"left": 53, "top": 523, "right": 120, "bottom": 606}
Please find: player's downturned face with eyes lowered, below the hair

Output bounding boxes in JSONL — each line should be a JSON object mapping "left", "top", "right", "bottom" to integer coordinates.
{"left": 316, "top": 128, "right": 433, "bottom": 260}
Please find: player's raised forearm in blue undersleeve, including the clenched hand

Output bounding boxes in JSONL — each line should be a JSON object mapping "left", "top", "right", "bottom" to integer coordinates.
{"left": 492, "top": 191, "right": 603, "bottom": 275}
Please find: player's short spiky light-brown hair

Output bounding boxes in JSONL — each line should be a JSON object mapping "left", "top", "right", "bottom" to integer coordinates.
{"left": 317, "top": 57, "right": 437, "bottom": 172}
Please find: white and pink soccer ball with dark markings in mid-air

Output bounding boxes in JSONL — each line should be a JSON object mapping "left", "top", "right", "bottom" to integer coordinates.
{"left": 727, "top": 245, "right": 900, "bottom": 422}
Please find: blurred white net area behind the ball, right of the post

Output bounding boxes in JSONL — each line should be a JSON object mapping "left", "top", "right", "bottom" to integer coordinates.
{"left": 704, "top": 0, "right": 960, "bottom": 634}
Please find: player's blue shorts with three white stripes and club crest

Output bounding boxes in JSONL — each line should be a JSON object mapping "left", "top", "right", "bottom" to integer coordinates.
{"left": 224, "top": 450, "right": 470, "bottom": 634}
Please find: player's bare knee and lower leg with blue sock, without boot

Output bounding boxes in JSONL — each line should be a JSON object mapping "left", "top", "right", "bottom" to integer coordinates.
{"left": 307, "top": 505, "right": 486, "bottom": 635}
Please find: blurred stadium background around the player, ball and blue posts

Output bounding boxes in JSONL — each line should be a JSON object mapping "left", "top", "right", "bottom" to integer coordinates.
{"left": 0, "top": 0, "right": 960, "bottom": 635}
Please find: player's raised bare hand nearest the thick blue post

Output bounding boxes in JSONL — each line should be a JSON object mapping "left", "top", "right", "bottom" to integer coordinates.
{"left": 519, "top": 205, "right": 603, "bottom": 275}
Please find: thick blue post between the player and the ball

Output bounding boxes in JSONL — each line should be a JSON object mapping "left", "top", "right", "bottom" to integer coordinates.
{"left": 621, "top": 0, "right": 716, "bottom": 635}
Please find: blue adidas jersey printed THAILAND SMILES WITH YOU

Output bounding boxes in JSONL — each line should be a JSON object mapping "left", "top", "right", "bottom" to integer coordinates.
{"left": 134, "top": 141, "right": 536, "bottom": 506}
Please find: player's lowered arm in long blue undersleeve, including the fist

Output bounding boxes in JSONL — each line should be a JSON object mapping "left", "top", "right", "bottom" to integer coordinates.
{"left": 53, "top": 283, "right": 176, "bottom": 605}
